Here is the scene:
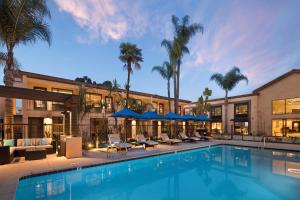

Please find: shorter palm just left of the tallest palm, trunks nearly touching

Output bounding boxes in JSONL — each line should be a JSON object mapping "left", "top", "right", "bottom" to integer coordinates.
{"left": 152, "top": 61, "right": 173, "bottom": 112}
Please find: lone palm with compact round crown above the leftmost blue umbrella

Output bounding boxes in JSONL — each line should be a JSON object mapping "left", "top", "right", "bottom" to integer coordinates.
{"left": 119, "top": 42, "right": 144, "bottom": 108}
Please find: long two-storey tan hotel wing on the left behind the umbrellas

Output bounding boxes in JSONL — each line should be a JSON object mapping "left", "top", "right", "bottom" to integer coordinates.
{"left": 0, "top": 71, "right": 191, "bottom": 138}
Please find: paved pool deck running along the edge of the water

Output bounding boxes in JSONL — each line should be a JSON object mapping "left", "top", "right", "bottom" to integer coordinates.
{"left": 0, "top": 140, "right": 300, "bottom": 200}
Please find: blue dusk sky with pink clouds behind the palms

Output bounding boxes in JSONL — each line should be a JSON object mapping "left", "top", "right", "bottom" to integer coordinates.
{"left": 0, "top": 0, "right": 300, "bottom": 101}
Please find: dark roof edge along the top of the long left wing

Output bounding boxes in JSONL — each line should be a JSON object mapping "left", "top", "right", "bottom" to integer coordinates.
{"left": 19, "top": 70, "right": 191, "bottom": 103}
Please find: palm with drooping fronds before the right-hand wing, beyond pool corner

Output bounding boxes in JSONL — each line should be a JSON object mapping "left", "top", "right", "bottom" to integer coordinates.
{"left": 210, "top": 67, "right": 248, "bottom": 138}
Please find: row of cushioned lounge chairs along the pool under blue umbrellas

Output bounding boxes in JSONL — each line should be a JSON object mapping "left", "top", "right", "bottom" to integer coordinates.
{"left": 108, "top": 133, "right": 209, "bottom": 151}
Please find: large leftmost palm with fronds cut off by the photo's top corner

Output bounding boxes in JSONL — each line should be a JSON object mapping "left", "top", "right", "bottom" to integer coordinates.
{"left": 0, "top": 0, "right": 51, "bottom": 138}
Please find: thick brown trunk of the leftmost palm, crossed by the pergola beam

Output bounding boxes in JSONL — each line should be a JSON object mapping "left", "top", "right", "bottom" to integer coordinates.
{"left": 4, "top": 48, "right": 14, "bottom": 139}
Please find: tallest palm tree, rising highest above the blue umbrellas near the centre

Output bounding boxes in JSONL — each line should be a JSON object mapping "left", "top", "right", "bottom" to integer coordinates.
{"left": 172, "top": 15, "right": 204, "bottom": 112}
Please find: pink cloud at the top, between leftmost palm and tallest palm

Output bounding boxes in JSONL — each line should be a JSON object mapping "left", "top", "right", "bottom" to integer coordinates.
{"left": 55, "top": 0, "right": 147, "bottom": 43}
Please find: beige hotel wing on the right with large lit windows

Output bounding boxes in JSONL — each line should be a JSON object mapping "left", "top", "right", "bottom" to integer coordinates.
{"left": 185, "top": 69, "right": 300, "bottom": 137}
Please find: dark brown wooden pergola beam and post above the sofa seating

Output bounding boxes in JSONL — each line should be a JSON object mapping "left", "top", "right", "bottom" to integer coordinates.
{"left": 0, "top": 85, "right": 79, "bottom": 136}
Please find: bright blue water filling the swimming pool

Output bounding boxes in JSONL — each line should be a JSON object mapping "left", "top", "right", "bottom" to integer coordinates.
{"left": 16, "top": 146, "right": 300, "bottom": 200}
